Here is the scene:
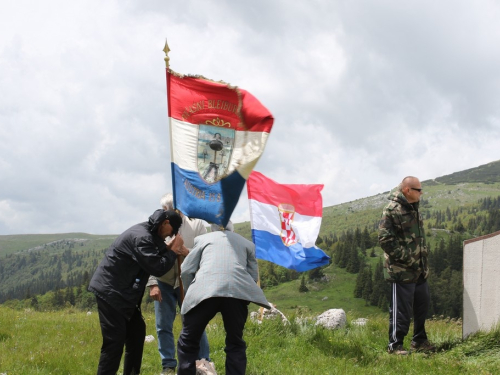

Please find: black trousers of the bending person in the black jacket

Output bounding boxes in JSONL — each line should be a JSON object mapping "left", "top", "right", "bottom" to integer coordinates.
{"left": 97, "top": 297, "right": 146, "bottom": 375}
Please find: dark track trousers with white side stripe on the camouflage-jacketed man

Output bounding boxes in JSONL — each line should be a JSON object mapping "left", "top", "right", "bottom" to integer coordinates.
{"left": 389, "top": 276, "right": 430, "bottom": 350}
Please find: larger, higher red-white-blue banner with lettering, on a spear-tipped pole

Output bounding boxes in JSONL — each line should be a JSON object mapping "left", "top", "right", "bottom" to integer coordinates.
{"left": 167, "top": 68, "right": 274, "bottom": 226}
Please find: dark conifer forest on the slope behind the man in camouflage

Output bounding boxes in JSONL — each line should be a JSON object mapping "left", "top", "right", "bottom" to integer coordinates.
{"left": 261, "top": 197, "right": 500, "bottom": 318}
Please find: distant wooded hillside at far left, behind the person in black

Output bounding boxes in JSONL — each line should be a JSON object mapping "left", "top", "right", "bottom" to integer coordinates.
{"left": 0, "top": 233, "right": 116, "bottom": 303}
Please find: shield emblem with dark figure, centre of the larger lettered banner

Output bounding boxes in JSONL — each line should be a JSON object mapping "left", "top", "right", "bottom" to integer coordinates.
{"left": 197, "top": 123, "right": 235, "bottom": 183}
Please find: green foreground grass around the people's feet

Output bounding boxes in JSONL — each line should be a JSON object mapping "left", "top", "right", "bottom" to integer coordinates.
{"left": 0, "top": 306, "right": 500, "bottom": 375}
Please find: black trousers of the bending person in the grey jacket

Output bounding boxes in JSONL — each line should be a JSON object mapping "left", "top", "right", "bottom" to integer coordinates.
{"left": 177, "top": 297, "right": 248, "bottom": 375}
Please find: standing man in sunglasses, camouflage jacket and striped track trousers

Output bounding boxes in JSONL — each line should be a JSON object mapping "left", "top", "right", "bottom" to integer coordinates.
{"left": 378, "top": 176, "right": 434, "bottom": 354}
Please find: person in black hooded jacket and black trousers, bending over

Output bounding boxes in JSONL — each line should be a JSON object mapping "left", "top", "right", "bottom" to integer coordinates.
{"left": 89, "top": 210, "right": 187, "bottom": 375}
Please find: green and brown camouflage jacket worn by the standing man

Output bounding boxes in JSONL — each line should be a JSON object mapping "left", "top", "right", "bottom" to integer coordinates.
{"left": 378, "top": 189, "right": 429, "bottom": 283}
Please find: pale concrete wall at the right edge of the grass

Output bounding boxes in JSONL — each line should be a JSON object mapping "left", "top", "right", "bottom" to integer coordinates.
{"left": 462, "top": 231, "right": 500, "bottom": 338}
